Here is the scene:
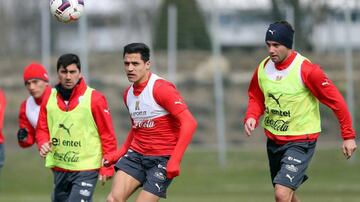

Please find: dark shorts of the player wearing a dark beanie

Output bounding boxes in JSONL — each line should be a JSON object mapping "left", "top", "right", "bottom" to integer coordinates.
{"left": 267, "top": 139, "right": 316, "bottom": 190}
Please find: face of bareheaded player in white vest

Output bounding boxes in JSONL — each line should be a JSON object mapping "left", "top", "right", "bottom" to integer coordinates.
{"left": 124, "top": 53, "right": 150, "bottom": 84}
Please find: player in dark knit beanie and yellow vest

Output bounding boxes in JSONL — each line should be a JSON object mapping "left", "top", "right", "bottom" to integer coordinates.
{"left": 244, "top": 21, "right": 356, "bottom": 202}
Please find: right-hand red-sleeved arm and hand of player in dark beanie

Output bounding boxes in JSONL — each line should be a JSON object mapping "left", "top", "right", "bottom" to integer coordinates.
{"left": 302, "top": 62, "right": 356, "bottom": 158}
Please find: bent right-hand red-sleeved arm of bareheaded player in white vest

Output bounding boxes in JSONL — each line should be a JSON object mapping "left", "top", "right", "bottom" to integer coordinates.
{"left": 154, "top": 80, "right": 197, "bottom": 178}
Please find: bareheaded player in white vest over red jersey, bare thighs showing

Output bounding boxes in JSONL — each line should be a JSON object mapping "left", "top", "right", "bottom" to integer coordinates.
{"left": 103, "top": 43, "right": 197, "bottom": 202}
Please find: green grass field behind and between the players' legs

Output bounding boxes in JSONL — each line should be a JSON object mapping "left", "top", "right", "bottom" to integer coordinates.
{"left": 0, "top": 147, "right": 360, "bottom": 202}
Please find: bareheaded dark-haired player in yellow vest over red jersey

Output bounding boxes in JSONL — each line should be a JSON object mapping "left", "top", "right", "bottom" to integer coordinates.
{"left": 36, "top": 54, "right": 117, "bottom": 202}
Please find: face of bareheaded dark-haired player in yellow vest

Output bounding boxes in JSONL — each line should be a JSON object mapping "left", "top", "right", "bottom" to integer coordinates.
{"left": 58, "top": 64, "right": 82, "bottom": 89}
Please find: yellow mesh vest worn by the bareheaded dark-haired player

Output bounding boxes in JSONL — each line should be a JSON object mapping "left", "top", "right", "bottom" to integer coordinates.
{"left": 45, "top": 87, "right": 102, "bottom": 170}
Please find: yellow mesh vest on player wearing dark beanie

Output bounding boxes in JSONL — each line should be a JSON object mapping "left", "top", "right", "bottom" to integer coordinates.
{"left": 258, "top": 53, "right": 321, "bottom": 136}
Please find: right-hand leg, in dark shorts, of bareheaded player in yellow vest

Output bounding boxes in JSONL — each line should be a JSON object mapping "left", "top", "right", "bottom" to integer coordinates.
{"left": 68, "top": 171, "right": 98, "bottom": 202}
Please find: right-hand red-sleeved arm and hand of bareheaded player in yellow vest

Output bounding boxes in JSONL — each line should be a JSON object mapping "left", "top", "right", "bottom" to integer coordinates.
{"left": 91, "top": 90, "right": 117, "bottom": 182}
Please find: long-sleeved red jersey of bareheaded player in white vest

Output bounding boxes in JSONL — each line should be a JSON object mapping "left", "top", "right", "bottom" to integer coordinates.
{"left": 104, "top": 73, "right": 197, "bottom": 178}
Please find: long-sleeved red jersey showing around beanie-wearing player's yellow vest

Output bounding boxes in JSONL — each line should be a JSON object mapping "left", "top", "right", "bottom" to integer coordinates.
{"left": 244, "top": 51, "right": 355, "bottom": 144}
